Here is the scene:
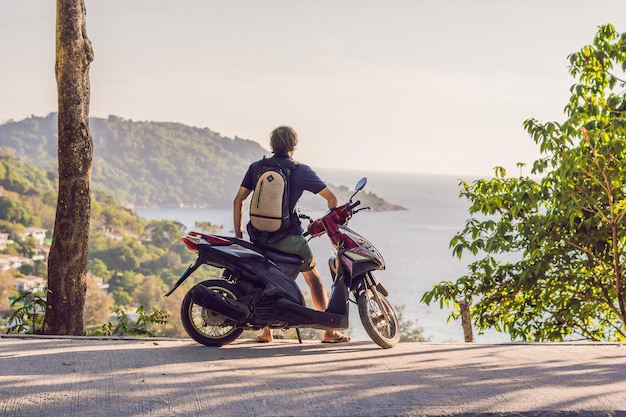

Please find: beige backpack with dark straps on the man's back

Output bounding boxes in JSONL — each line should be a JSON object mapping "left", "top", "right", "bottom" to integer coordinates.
{"left": 249, "top": 157, "right": 298, "bottom": 241}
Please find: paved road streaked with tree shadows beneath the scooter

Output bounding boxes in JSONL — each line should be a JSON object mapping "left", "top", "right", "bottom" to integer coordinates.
{"left": 0, "top": 336, "right": 626, "bottom": 417}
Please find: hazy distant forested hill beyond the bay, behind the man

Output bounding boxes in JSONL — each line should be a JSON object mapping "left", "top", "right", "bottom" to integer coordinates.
{"left": 0, "top": 113, "right": 399, "bottom": 210}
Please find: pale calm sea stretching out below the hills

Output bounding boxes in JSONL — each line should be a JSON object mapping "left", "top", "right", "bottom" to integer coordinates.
{"left": 136, "top": 169, "right": 510, "bottom": 343}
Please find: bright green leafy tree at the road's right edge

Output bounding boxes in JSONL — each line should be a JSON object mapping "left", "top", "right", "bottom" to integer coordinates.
{"left": 422, "top": 25, "right": 626, "bottom": 341}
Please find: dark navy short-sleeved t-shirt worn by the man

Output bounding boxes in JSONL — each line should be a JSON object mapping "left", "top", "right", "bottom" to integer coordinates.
{"left": 241, "top": 155, "right": 326, "bottom": 235}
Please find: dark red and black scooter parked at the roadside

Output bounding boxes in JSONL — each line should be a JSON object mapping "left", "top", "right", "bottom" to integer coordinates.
{"left": 165, "top": 178, "right": 400, "bottom": 349}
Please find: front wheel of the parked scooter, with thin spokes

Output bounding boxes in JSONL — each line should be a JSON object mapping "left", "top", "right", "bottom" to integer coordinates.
{"left": 357, "top": 288, "right": 400, "bottom": 349}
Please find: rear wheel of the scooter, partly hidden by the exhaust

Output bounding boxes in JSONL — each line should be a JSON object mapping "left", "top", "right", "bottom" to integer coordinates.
{"left": 180, "top": 279, "right": 243, "bottom": 346}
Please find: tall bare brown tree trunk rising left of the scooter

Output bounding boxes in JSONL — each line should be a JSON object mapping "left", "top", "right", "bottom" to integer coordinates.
{"left": 43, "top": 0, "right": 93, "bottom": 335}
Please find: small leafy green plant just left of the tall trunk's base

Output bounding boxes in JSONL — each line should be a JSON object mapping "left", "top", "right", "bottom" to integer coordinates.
{"left": 7, "top": 290, "right": 46, "bottom": 334}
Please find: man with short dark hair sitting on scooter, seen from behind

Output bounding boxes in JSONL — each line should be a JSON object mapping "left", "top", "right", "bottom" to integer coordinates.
{"left": 233, "top": 126, "right": 350, "bottom": 343}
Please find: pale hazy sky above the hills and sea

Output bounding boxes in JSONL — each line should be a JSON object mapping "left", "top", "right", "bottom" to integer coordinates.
{"left": 0, "top": 0, "right": 626, "bottom": 176}
